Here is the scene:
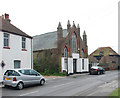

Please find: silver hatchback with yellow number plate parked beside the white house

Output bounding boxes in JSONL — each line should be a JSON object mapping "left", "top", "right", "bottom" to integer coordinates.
{"left": 3, "top": 69, "right": 45, "bottom": 90}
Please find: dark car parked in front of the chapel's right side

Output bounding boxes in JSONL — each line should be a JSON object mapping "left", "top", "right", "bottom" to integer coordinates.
{"left": 89, "top": 66, "right": 105, "bottom": 75}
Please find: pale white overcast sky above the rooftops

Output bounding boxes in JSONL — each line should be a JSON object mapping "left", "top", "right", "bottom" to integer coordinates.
{"left": 0, "top": 0, "right": 119, "bottom": 54}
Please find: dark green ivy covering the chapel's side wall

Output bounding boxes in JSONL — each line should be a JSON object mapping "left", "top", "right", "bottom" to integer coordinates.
{"left": 33, "top": 51, "right": 59, "bottom": 75}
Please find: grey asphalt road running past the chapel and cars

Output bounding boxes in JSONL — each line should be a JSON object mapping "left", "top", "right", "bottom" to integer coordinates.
{"left": 2, "top": 71, "right": 118, "bottom": 96}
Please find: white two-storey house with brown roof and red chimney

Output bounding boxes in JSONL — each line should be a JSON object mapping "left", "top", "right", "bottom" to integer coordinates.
{"left": 0, "top": 14, "right": 33, "bottom": 82}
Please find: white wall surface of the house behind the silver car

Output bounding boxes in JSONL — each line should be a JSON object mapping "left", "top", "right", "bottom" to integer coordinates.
{"left": 2, "top": 31, "right": 31, "bottom": 82}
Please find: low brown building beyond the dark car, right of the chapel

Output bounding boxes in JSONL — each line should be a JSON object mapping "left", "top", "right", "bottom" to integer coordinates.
{"left": 89, "top": 47, "right": 120, "bottom": 69}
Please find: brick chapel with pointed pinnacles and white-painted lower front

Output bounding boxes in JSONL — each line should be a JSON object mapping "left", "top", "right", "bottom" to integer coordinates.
{"left": 33, "top": 20, "right": 89, "bottom": 74}
